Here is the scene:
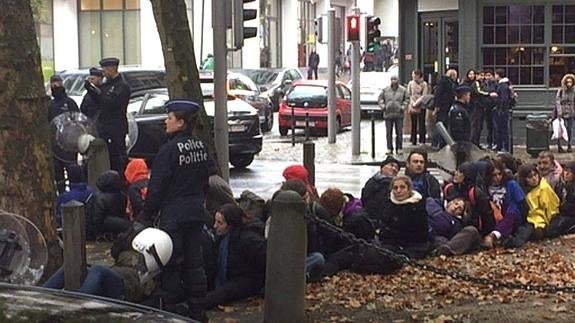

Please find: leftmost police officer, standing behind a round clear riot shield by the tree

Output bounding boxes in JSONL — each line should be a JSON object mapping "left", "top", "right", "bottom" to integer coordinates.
{"left": 48, "top": 75, "right": 80, "bottom": 194}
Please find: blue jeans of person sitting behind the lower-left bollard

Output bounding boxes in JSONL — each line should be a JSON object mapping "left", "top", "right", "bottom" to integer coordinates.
{"left": 44, "top": 265, "right": 126, "bottom": 300}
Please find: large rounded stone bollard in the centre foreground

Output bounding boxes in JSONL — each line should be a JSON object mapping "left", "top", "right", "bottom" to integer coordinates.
{"left": 264, "top": 191, "right": 307, "bottom": 323}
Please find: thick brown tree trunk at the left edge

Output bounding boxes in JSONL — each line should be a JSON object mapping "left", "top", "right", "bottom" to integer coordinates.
{"left": 0, "top": 0, "right": 62, "bottom": 277}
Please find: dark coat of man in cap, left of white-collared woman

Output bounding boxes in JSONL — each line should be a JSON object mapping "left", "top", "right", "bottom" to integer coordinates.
{"left": 361, "top": 171, "right": 393, "bottom": 223}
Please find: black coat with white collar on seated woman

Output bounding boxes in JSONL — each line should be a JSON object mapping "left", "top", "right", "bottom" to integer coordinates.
{"left": 379, "top": 191, "right": 429, "bottom": 247}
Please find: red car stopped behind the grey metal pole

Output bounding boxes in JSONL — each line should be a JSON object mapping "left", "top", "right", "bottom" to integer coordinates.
{"left": 278, "top": 80, "right": 351, "bottom": 136}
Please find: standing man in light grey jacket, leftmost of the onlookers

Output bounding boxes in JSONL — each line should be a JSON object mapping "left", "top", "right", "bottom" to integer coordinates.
{"left": 377, "top": 75, "right": 409, "bottom": 155}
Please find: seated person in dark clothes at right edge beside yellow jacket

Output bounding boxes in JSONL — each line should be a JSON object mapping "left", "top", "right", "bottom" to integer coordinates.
{"left": 547, "top": 162, "right": 575, "bottom": 238}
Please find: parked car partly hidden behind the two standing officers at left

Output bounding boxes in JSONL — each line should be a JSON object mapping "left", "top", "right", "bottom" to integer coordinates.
{"left": 58, "top": 66, "right": 166, "bottom": 106}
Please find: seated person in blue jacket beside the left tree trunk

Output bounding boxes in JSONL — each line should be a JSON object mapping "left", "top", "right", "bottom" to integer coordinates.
{"left": 56, "top": 165, "right": 94, "bottom": 227}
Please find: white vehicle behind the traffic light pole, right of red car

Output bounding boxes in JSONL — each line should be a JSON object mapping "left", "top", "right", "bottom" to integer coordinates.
{"left": 347, "top": 72, "right": 397, "bottom": 118}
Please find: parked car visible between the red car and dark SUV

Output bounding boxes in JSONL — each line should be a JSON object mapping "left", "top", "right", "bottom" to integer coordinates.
{"left": 235, "top": 68, "right": 304, "bottom": 111}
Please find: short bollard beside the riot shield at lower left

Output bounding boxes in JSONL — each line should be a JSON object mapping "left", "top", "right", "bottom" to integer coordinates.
{"left": 62, "top": 201, "right": 86, "bottom": 291}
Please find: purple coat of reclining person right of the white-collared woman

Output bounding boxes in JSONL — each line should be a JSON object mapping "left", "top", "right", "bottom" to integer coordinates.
{"left": 425, "top": 198, "right": 464, "bottom": 239}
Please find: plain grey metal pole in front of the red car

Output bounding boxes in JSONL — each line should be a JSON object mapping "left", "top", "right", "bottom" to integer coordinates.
{"left": 327, "top": 8, "right": 337, "bottom": 144}
